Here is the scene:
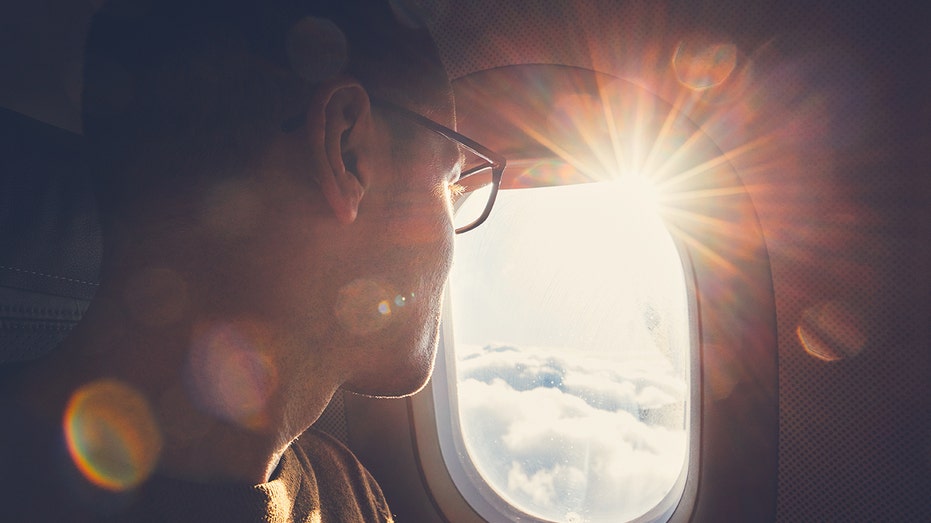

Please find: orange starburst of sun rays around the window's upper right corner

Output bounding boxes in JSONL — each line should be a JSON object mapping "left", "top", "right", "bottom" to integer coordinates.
{"left": 444, "top": 2, "right": 891, "bottom": 368}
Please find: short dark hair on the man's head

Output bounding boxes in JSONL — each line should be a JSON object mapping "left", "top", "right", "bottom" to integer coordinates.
{"left": 83, "top": 0, "right": 451, "bottom": 229}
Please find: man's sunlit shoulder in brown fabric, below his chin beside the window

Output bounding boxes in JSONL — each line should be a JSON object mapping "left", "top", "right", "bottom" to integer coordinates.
{"left": 292, "top": 429, "right": 393, "bottom": 521}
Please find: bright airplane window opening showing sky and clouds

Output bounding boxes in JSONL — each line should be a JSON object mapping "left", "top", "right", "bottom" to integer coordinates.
{"left": 443, "top": 177, "right": 692, "bottom": 522}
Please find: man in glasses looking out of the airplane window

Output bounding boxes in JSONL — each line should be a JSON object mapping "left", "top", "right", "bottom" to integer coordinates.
{"left": 0, "top": 0, "right": 500, "bottom": 521}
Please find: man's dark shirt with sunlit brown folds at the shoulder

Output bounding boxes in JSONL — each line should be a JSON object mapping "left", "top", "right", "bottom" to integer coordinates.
{"left": 0, "top": 366, "right": 392, "bottom": 523}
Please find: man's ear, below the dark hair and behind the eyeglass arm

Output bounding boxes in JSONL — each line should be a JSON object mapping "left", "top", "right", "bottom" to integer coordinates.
{"left": 307, "top": 77, "right": 372, "bottom": 224}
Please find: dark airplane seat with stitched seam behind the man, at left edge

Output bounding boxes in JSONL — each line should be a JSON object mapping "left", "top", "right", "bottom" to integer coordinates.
{"left": 0, "top": 108, "right": 101, "bottom": 363}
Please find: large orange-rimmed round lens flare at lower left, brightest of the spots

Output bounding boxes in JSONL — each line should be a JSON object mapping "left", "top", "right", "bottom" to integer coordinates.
{"left": 63, "top": 379, "right": 162, "bottom": 492}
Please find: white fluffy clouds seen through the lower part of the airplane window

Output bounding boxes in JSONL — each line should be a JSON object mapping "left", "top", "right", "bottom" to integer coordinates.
{"left": 457, "top": 346, "right": 687, "bottom": 521}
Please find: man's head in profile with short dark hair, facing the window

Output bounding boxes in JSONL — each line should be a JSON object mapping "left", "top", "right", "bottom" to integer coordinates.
{"left": 84, "top": 0, "right": 458, "bottom": 406}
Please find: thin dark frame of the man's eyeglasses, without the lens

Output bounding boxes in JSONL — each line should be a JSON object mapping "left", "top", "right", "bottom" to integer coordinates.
{"left": 281, "top": 98, "right": 507, "bottom": 234}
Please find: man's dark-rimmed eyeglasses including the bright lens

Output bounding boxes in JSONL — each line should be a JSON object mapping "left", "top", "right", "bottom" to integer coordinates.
{"left": 281, "top": 99, "right": 507, "bottom": 234}
